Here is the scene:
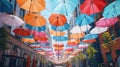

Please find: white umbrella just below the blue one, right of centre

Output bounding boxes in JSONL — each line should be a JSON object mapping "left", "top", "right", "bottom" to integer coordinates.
{"left": 70, "top": 25, "right": 91, "bottom": 34}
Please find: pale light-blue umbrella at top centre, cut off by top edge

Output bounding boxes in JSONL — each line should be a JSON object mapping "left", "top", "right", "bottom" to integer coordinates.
{"left": 52, "top": 0, "right": 78, "bottom": 16}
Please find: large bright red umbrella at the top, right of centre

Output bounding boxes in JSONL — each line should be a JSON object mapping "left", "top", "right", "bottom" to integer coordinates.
{"left": 80, "top": 0, "right": 107, "bottom": 15}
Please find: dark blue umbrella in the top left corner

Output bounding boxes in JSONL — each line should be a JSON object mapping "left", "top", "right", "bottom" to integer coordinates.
{"left": 0, "top": 0, "right": 13, "bottom": 13}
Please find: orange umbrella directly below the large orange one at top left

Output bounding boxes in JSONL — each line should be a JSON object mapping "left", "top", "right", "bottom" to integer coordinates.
{"left": 24, "top": 13, "right": 46, "bottom": 26}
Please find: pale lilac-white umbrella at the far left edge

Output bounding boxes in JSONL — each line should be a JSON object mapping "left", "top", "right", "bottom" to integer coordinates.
{"left": 0, "top": 14, "right": 25, "bottom": 27}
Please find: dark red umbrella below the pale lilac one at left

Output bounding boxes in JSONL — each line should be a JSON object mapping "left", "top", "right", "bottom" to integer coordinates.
{"left": 13, "top": 28, "right": 30, "bottom": 36}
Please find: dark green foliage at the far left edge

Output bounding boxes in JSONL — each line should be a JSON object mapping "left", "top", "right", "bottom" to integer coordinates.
{"left": 0, "top": 27, "right": 8, "bottom": 50}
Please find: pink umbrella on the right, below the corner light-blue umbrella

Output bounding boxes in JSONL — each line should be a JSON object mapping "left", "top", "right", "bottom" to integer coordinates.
{"left": 96, "top": 17, "right": 118, "bottom": 27}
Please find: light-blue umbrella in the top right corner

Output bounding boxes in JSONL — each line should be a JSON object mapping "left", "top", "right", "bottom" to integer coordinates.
{"left": 103, "top": 0, "right": 120, "bottom": 18}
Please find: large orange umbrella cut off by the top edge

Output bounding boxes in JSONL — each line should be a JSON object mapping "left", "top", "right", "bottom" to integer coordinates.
{"left": 17, "top": 0, "right": 46, "bottom": 12}
